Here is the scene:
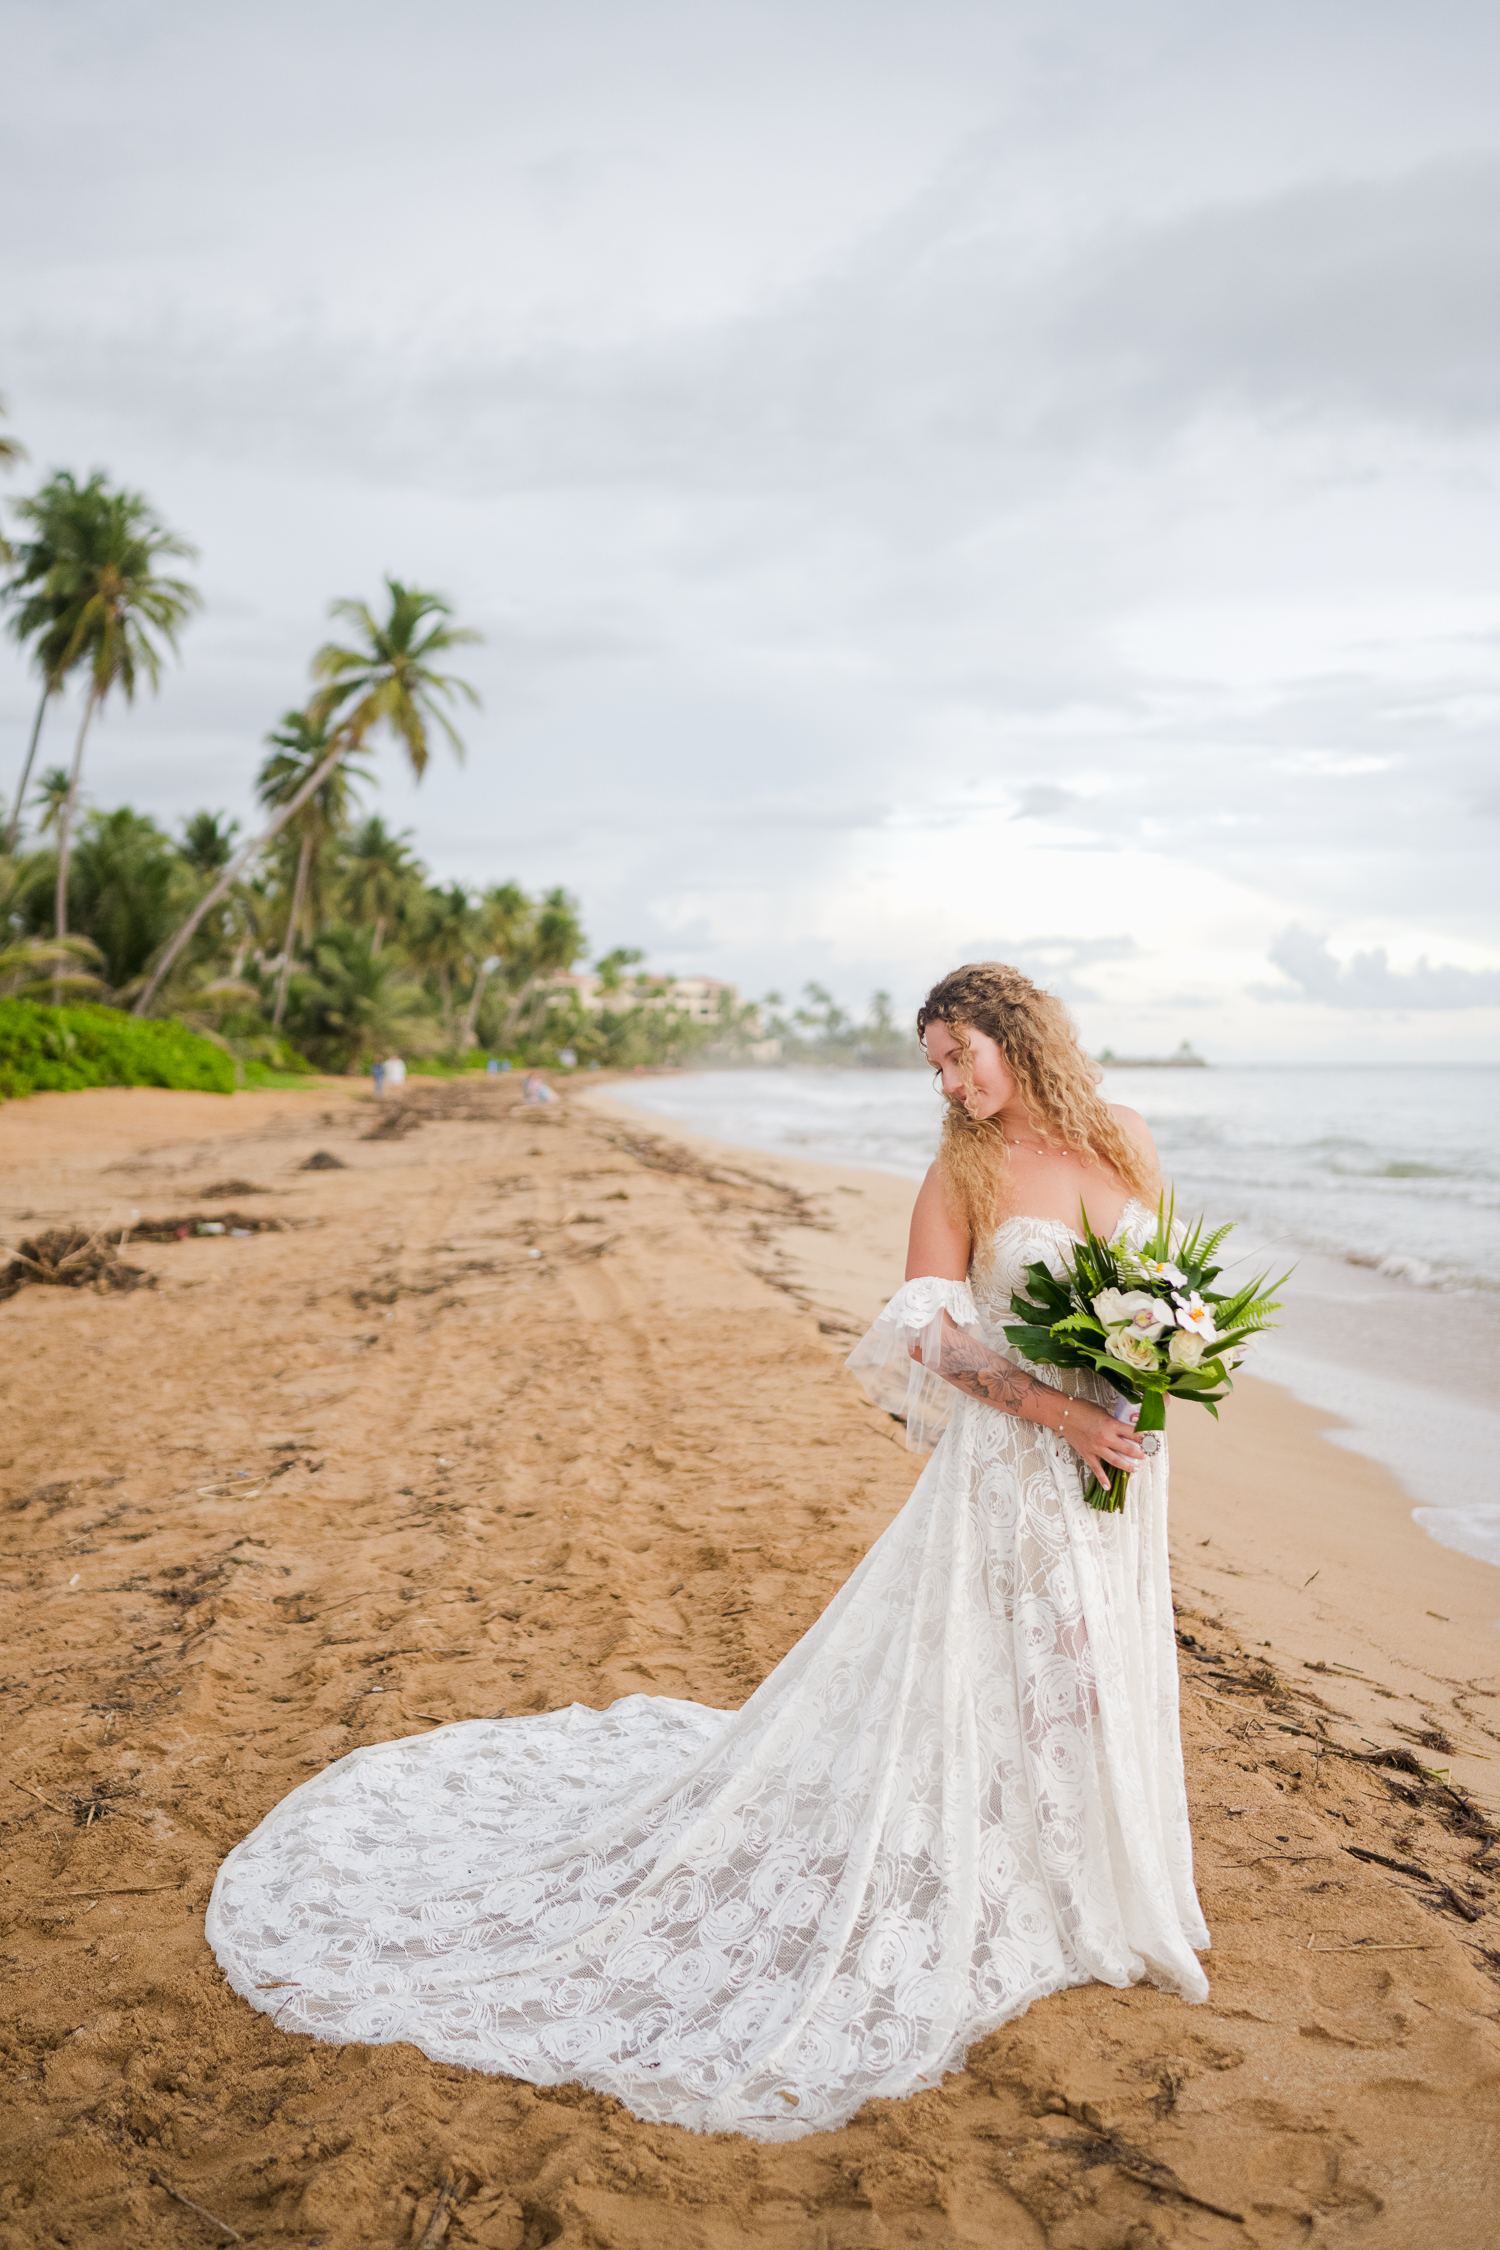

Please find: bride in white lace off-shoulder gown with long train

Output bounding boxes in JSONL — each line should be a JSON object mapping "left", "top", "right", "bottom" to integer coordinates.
{"left": 207, "top": 963, "right": 1208, "bottom": 2140}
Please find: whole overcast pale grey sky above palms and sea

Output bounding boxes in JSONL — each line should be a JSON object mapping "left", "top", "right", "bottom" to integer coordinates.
{"left": 0, "top": 0, "right": 1500, "bottom": 1060}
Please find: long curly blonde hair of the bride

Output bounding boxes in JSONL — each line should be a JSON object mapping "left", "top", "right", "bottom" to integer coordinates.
{"left": 918, "top": 961, "right": 1160, "bottom": 1271}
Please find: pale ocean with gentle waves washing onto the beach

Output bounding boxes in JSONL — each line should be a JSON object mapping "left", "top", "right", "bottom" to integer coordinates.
{"left": 612, "top": 1064, "right": 1500, "bottom": 1566}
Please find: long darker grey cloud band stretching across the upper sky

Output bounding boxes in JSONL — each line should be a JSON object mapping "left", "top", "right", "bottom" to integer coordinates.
{"left": 11, "top": 155, "right": 1500, "bottom": 513}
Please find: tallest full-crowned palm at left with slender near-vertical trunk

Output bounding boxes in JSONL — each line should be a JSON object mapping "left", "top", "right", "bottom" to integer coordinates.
{"left": 25, "top": 493, "right": 200, "bottom": 938}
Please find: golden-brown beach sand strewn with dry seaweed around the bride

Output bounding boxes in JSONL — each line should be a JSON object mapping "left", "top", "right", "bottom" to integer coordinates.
{"left": 0, "top": 1085, "right": 1500, "bottom": 2250}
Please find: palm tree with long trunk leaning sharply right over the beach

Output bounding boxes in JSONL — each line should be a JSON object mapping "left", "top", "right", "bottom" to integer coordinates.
{"left": 135, "top": 578, "right": 481, "bottom": 1015}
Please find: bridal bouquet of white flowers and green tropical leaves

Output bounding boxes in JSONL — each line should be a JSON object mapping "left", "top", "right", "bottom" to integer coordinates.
{"left": 1005, "top": 1202, "right": 1286, "bottom": 1512}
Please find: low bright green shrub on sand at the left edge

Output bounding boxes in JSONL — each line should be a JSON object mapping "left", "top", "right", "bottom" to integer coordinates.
{"left": 0, "top": 999, "right": 234, "bottom": 1098}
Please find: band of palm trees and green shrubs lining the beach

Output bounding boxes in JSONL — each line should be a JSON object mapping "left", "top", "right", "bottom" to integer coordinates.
{"left": 0, "top": 441, "right": 814, "bottom": 1094}
